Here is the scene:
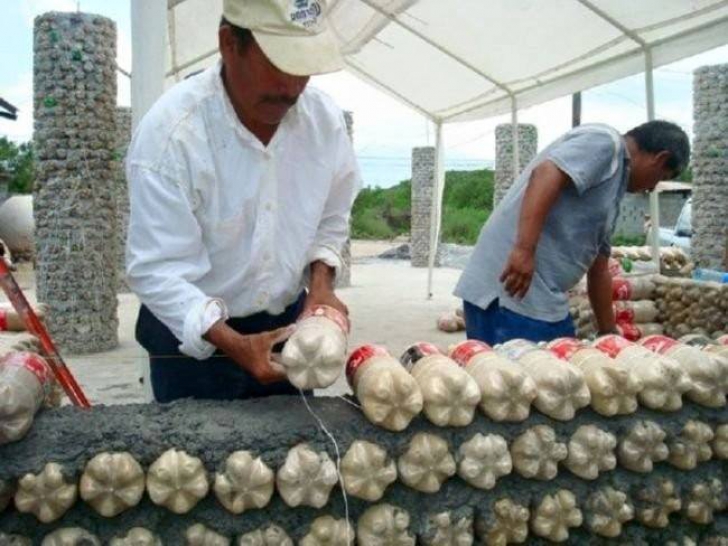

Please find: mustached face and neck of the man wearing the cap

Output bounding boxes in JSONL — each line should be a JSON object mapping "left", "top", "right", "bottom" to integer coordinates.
{"left": 219, "top": 26, "right": 309, "bottom": 126}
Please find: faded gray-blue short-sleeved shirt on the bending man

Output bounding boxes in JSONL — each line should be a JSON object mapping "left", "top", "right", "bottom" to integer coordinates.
{"left": 455, "top": 124, "right": 629, "bottom": 322}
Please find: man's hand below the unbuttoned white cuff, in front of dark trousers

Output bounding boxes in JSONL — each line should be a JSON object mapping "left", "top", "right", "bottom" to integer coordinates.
{"left": 205, "top": 320, "right": 293, "bottom": 385}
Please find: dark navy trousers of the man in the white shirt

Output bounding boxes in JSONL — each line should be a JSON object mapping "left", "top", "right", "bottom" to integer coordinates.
{"left": 136, "top": 292, "right": 306, "bottom": 402}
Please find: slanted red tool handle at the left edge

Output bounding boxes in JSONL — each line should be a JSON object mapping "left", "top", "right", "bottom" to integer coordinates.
{"left": 0, "top": 257, "right": 91, "bottom": 408}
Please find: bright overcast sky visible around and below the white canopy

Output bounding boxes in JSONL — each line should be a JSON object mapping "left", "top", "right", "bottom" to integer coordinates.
{"left": 0, "top": 0, "right": 728, "bottom": 164}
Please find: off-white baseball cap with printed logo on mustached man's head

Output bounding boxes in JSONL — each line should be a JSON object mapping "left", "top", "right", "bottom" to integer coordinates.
{"left": 223, "top": 0, "right": 344, "bottom": 76}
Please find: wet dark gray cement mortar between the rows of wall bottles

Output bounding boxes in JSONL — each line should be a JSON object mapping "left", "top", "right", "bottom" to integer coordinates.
{"left": 0, "top": 397, "right": 728, "bottom": 544}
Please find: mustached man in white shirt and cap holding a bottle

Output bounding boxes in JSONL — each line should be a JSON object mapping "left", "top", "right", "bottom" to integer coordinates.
{"left": 126, "top": 0, "right": 360, "bottom": 402}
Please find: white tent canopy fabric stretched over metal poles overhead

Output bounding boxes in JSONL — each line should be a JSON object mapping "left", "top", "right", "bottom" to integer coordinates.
{"left": 167, "top": 0, "right": 728, "bottom": 123}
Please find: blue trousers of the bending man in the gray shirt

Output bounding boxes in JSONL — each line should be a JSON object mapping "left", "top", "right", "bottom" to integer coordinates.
{"left": 463, "top": 299, "right": 576, "bottom": 345}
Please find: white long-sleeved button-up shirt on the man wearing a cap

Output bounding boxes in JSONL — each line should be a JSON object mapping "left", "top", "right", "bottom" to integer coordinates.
{"left": 126, "top": 64, "right": 361, "bottom": 359}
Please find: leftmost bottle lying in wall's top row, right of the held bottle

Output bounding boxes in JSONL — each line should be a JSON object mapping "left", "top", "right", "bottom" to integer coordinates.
{"left": 346, "top": 345, "right": 422, "bottom": 432}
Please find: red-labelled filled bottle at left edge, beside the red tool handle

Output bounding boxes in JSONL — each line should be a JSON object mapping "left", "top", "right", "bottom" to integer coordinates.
{"left": 0, "top": 352, "right": 53, "bottom": 445}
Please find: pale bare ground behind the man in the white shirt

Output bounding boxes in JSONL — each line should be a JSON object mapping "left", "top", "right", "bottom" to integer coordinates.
{"left": 0, "top": 241, "right": 464, "bottom": 404}
